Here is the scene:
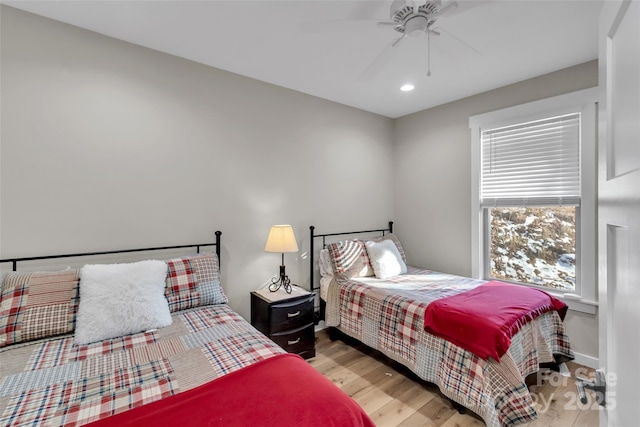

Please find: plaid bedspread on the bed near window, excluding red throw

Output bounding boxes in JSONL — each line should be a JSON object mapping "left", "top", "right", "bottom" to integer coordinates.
{"left": 327, "top": 267, "right": 573, "bottom": 427}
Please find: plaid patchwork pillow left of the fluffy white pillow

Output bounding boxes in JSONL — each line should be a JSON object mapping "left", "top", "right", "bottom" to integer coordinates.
{"left": 0, "top": 269, "right": 79, "bottom": 347}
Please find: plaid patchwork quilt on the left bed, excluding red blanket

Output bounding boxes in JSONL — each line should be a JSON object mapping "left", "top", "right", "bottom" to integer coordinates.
{"left": 0, "top": 305, "right": 285, "bottom": 426}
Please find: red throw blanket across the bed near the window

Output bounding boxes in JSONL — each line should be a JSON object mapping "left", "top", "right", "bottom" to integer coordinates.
{"left": 424, "top": 281, "right": 567, "bottom": 361}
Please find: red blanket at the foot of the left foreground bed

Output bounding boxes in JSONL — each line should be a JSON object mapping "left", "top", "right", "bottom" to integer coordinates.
{"left": 90, "top": 354, "right": 375, "bottom": 427}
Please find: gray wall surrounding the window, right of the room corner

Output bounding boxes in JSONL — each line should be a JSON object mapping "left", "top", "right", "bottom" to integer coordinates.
{"left": 394, "top": 61, "right": 598, "bottom": 358}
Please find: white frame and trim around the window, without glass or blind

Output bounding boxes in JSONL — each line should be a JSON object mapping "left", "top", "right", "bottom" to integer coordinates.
{"left": 469, "top": 88, "right": 598, "bottom": 314}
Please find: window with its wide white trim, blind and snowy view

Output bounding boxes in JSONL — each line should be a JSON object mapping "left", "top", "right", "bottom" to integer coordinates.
{"left": 470, "top": 89, "right": 597, "bottom": 312}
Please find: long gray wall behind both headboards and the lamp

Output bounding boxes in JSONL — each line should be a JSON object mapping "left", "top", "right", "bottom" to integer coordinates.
{"left": 0, "top": 6, "right": 394, "bottom": 318}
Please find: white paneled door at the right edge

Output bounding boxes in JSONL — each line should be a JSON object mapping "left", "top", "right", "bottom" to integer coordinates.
{"left": 598, "top": 0, "right": 640, "bottom": 427}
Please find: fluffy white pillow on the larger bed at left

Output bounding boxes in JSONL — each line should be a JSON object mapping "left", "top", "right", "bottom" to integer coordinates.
{"left": 74, "top": 261, "right": 171, "bottom": 344}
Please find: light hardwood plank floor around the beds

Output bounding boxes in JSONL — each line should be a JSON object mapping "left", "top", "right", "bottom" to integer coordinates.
{"left": 309, "top": 331, "right": 599, "bottom": 427}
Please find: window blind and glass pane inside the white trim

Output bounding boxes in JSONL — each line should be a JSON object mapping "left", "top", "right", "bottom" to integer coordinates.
{"left": 480, "top": 113, "right": 580, "bottom": 292}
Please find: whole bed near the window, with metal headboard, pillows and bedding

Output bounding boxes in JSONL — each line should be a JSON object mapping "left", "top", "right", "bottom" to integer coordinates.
{"left": 310, "top": 222, "right": 573, "bottom": 427}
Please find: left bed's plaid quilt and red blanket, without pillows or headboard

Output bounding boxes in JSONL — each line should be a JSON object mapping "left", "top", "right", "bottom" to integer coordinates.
{"left": 0, "top": 305, "right": 373, "bottom": 427}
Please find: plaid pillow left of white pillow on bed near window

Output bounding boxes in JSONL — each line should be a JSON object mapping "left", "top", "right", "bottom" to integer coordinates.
{"left": 327, "top": 240, "right": 373, "bottom": 279}
